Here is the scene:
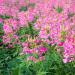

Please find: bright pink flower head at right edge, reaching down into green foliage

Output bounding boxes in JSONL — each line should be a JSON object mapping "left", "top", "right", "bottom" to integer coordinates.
{"left": 63, "top": 37, "right": 75, "bottom": 62}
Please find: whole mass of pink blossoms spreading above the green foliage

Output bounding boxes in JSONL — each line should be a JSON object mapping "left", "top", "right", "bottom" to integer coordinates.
{"left": 0, "top": 0, "right": 75, "bottom": 63}
